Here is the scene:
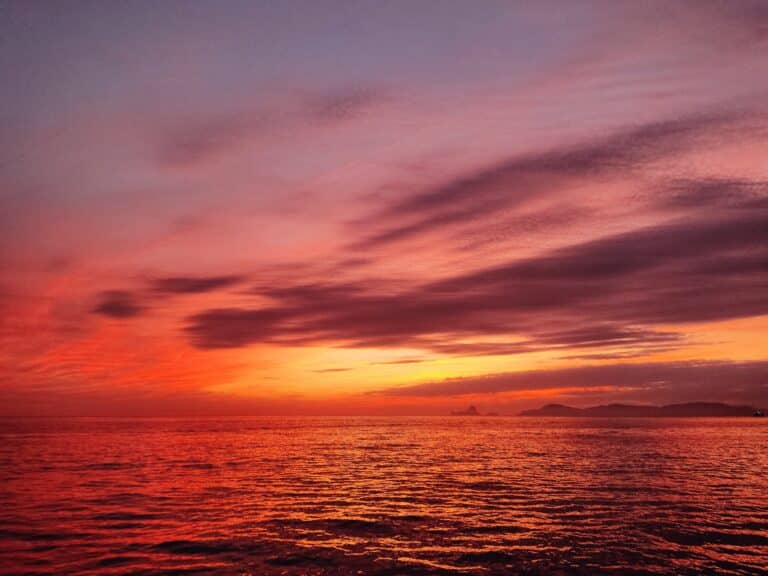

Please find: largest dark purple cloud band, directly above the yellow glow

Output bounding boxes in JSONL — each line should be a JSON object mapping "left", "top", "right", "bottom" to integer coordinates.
{"left": 186, "top": 202, "right": 768, "bottom": 354}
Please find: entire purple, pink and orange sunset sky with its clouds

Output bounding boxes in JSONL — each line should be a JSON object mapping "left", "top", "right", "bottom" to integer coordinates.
{"left": 0, "top": 0, "right": 768, "bottom": 416}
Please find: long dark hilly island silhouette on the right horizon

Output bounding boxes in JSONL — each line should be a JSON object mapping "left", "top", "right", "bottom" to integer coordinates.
{"left": 520, "top": 402, "right": 757, "bottom": 417}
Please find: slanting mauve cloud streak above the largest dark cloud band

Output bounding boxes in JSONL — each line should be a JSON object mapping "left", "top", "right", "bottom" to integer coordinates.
{"left": 351, "top": 112, "right": 745, "bottom": 250}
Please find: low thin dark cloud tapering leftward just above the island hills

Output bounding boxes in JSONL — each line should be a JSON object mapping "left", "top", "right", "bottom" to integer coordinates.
{"left": 373, "top": 361, "right": 768, "bottom": 402}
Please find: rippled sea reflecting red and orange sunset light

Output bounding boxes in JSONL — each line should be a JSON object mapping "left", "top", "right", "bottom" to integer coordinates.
{"left": 0, "top": 417, "right": 768, "bottom": 575}
